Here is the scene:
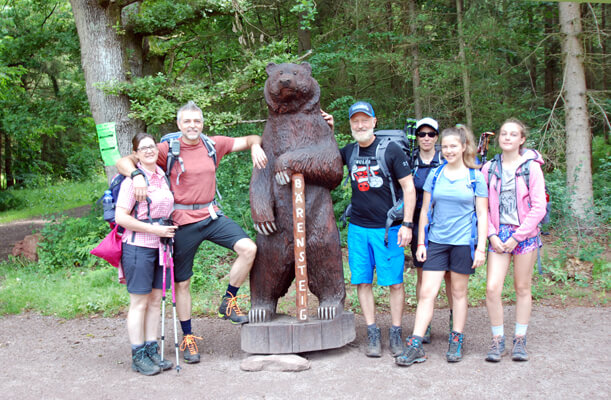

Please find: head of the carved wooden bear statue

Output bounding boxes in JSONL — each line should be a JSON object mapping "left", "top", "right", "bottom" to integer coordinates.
{"left": 264, "top": 62, "right": 320, "bottom": 114}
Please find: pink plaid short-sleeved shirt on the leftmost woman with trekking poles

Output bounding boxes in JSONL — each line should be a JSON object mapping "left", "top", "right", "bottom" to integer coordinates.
{"left": 117, "top": 163, "right": 174, "bottom": 249}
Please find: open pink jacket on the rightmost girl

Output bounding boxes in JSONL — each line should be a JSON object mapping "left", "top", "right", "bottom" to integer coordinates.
{"left": 482, "top": 149, "right": 547, "bottom": 243}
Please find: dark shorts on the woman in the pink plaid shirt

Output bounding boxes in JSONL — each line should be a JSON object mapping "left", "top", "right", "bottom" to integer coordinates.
{"left": 121, "top": 243, "right": 170, "bottom": 294}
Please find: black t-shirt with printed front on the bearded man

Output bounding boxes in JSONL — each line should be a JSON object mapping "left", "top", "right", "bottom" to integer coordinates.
{"left": 340, "top": 138, "right": 411, "bottom": 228}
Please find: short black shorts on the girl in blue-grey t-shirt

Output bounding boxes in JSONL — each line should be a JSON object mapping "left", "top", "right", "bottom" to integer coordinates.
{"left": 422, "top": 241, "right": 475, "bottom": 275}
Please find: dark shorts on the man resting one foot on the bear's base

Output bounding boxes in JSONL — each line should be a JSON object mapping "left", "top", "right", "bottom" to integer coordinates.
{"left": 174, "top": 215, "right": 248, "bottom": 282}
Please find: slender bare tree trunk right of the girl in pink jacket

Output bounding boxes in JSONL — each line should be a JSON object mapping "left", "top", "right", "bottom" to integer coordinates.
{"left": 558, "top": 2, "right": 593, "bottom": 222}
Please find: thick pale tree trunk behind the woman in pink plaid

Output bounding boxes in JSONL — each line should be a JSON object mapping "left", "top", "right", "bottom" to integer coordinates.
{"left": 70, "top": 0, "right": 145, "bottom": 176}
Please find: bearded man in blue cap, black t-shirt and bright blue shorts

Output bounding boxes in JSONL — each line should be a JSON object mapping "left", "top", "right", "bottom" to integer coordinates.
{"left": 332, "top": 101, "right": 416, "bottom": 357}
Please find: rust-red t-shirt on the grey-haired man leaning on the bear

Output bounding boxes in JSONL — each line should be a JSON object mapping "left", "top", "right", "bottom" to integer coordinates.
{"left": 157, "top": 136, "right": 235, "bottom": 225}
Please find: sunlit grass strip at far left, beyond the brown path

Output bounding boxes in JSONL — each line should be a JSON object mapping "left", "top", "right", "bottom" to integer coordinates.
{"left": 0, "top": 175, "right": 108, "bottom": 223}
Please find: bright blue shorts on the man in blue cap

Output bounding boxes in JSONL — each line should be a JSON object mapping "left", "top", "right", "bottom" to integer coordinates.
{"left": 348, "top": 224, "right": 405, "bottom": 286}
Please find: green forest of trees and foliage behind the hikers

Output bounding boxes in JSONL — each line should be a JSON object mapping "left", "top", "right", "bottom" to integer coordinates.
{"left": 0, "top": 0, "right": 611, "bottom": 313}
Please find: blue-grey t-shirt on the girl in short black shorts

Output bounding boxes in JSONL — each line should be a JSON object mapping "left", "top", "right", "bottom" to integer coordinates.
{"left": 424, "top": 167, "right": 488, "bottom": 246}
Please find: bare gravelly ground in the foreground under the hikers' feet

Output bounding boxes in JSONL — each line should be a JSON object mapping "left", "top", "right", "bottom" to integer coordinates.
{"left": 0, "top": 306, "right": 611, "bottom": 400}
